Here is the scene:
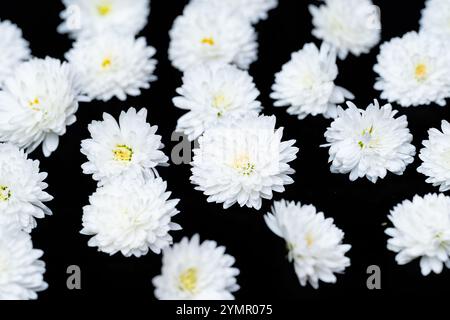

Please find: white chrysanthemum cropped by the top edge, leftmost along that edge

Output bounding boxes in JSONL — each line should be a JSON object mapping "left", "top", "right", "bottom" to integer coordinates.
{"left": 58, "top": 0, "right": 150, "bottom": 38}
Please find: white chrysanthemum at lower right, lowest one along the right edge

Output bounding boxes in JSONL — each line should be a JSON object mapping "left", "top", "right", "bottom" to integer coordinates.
{"left": 386, "top": 194, "right": 450, "bottom": 276}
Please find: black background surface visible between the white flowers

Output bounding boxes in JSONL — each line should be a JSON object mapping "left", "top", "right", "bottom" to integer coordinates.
{"left": 0, "top": 0, "right": 450, "bottom": 301}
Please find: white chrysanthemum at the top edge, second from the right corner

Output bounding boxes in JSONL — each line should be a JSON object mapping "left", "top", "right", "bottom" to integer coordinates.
{"left": 309, "top": 0, "right": 381, "bottom": 59}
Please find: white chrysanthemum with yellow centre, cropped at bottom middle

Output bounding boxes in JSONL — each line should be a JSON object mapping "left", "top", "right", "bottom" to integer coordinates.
{"left": 153, "top": 234, "right": 239, "bottom": 300}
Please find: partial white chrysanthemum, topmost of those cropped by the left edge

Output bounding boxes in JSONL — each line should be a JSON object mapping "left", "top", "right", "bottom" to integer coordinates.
{"left": 0, "top": 21, "right": 30, "bottom": 88}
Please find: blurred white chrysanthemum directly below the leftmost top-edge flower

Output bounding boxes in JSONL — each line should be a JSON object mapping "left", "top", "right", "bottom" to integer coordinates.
{"left": 66, "top": 33, "right": 156, "bottom": 101}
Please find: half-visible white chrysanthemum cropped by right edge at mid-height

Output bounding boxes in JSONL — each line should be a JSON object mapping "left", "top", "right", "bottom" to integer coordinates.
{"left": 417, "top": 120, "right": 450, "bottom": 192}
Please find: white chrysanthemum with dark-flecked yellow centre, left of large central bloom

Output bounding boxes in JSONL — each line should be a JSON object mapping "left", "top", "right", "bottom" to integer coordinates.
{"left": 81, "top": 108, "right": 169, "bottom": 184}
